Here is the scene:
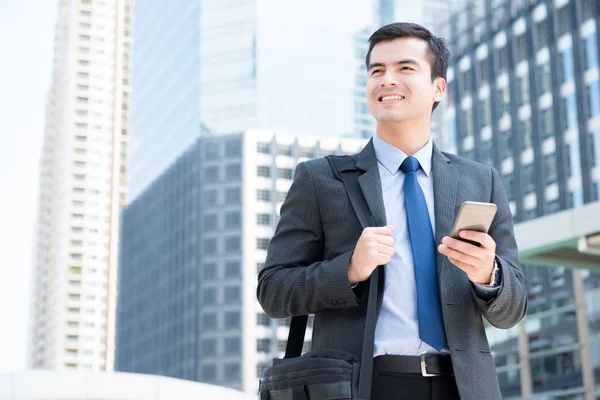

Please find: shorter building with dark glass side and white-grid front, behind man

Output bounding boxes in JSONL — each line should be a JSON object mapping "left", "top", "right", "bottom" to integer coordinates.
{"left": 116, "top": 130, "right": 366, "bottom": 393}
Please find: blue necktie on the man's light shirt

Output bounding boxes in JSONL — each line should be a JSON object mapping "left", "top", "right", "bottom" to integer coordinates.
{"left": 400, "top": 157, "right": 446, "bottom": 350}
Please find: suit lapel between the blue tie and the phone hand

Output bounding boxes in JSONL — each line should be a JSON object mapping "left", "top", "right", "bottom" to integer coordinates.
{"left": 432, "top": 144, "right": 458, "bottom": 282}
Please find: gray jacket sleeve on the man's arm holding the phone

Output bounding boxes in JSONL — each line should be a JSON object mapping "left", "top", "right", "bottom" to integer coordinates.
{"left": 474, "top": 169, "right": 527, "bottom": 329}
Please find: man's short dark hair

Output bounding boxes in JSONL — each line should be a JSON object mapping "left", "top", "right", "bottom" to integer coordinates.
{"left": 365, "top": 22, "right": 450, "bottom": 109}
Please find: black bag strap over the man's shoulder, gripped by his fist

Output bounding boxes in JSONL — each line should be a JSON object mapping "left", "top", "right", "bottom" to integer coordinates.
{"left": 285, "top": 155, "right": 379, "bottom": 399}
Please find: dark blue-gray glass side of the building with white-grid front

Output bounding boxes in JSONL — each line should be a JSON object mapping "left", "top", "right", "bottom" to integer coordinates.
{"left": 116, "top": 135, "right": 243, "bottom": 389}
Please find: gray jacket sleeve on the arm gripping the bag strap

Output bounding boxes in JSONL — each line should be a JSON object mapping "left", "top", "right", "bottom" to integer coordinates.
{"left": 256, "top": 163, "right": 358, "bottom": 318}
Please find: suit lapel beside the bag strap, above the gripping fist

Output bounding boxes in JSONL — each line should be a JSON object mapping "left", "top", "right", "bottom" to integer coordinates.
{"left": 356, "top": 139, "right": 387, "bottom": 226}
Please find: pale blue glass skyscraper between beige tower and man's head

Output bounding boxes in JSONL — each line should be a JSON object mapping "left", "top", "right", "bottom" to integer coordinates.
{"left": 129, "top": 0, "right": 372, "bottom": 199}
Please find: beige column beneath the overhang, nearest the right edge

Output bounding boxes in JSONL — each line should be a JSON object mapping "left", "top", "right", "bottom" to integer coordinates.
{"left": 573, "top": 269, "right": 596, "bottom": 400}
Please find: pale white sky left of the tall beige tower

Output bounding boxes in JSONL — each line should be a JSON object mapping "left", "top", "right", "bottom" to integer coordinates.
{"left": 0, "top": 0, "right": 57, "bottom": 373}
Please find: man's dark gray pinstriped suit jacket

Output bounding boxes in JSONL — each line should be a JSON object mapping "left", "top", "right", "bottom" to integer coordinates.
{"left": 257, "top": 141, "right": 527, "bottom": 400}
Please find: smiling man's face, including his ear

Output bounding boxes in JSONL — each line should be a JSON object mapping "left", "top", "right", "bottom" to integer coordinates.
{"left": 367, "top": 38, "right": 446, "bottom": 123}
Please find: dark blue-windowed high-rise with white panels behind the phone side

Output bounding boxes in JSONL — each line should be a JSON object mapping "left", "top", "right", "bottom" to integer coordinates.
{"left": 441, "top": 0, "right": 600, "bottom": 399}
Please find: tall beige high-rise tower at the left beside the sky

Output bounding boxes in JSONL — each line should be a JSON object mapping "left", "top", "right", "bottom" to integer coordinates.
{"left": 28, "top": 0, "right": 133, "bottom": 371}
